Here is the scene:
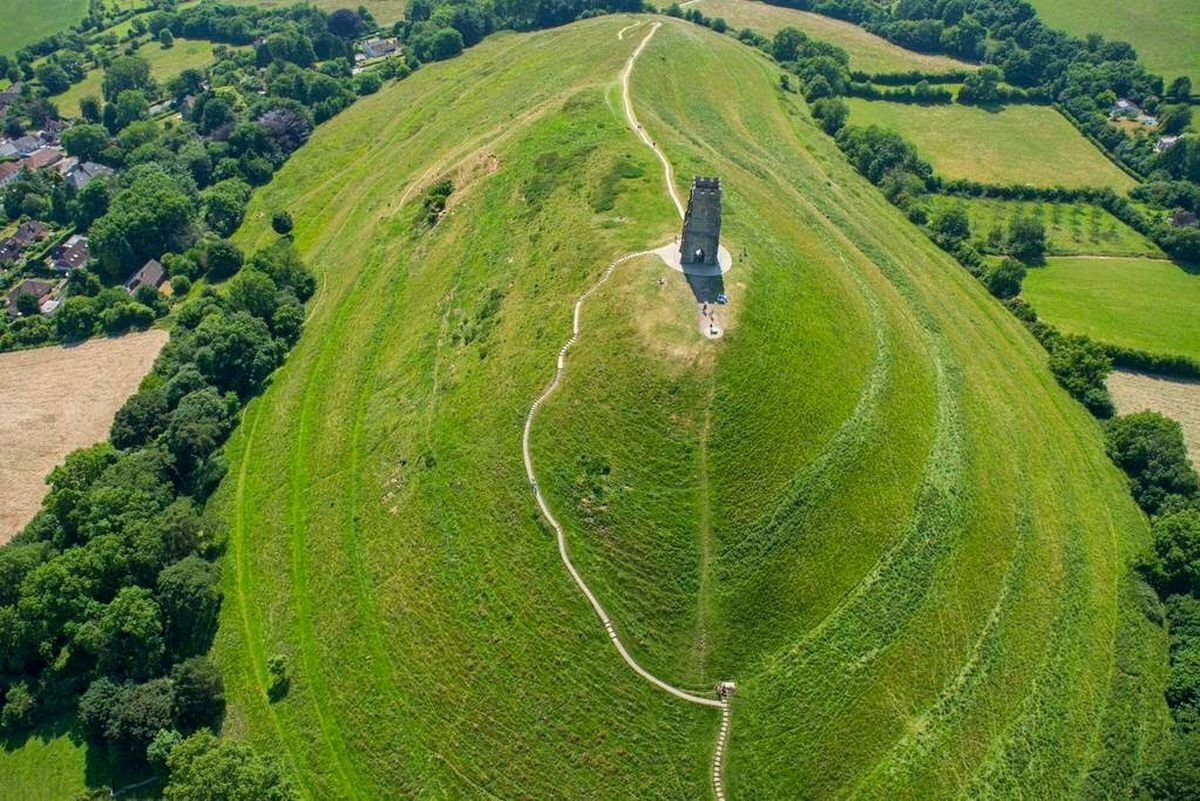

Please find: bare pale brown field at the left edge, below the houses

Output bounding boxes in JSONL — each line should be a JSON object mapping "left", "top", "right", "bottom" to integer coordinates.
{"left": 0, "top": 330, "right": 167, "bottom": 543}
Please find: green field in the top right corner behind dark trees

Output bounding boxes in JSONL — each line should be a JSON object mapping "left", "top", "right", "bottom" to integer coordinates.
{"left": 1031, "top": 0, "right": 1200, "bottom": 91}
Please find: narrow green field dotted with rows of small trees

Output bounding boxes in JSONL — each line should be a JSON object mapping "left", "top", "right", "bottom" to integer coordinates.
{"left": 930, "top": 195, "right": 1165, "bottom": 259}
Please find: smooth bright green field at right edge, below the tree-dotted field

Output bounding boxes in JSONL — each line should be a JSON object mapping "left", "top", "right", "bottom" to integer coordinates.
{"left": 1022, "top": 257, "right": 1200, "bottom": 359}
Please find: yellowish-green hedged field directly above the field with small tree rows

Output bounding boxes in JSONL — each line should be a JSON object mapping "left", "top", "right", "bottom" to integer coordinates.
{"left": 847, "top": 97, "right": 1134, "bottom": 192}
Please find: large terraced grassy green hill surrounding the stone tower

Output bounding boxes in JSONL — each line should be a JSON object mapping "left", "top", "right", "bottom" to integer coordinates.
{"left": 217, "top": 17, "right": 1165, "bottom": 799}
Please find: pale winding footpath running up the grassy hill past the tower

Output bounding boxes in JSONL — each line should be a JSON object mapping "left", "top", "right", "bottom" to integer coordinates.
{"left": 521, "top": 23, "right": 732, "bottom": 801}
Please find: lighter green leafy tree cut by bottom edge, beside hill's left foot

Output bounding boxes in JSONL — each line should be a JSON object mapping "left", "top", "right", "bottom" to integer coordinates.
{"left": 163, "top": 731, "right": 299, "bottom": 801}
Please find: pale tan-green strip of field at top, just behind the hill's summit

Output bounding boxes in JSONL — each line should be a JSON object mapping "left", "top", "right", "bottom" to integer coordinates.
{"left": 688, "top": 0, "right": 974, "bottom": 74}
